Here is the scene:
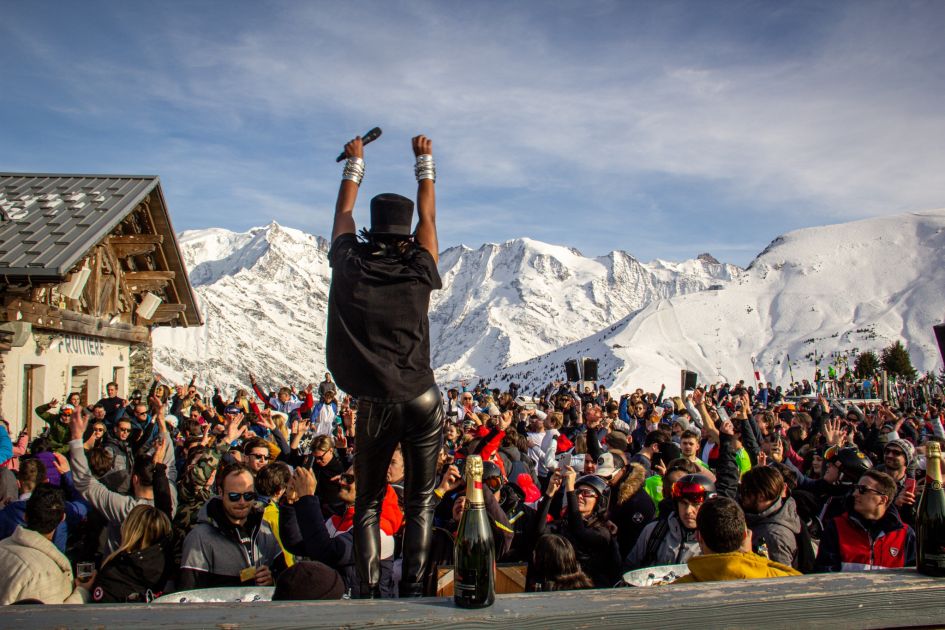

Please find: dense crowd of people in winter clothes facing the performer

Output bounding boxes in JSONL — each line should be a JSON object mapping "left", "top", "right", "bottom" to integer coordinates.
{"left": 0, "top": 374, "right": 945, "bottom": 604}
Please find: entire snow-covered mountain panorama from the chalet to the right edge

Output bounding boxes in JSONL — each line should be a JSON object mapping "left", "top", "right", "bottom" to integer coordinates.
{"left": 154, "top": 210, "right": 945, "bottom": 396}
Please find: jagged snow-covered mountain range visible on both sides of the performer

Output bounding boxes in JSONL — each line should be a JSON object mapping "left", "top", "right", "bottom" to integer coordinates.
{"left": 154, "top": 223, "right": 744, "bottom": 387}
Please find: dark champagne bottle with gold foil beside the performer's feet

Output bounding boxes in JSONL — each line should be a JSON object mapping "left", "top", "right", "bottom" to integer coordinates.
{"left": 453, "top": 455, "right": 495, "bottom": 608}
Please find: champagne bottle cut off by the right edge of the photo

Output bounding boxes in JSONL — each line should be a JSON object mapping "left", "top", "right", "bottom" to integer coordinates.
{"left": 915, "top": 442, "right": 945, "bottom": 577}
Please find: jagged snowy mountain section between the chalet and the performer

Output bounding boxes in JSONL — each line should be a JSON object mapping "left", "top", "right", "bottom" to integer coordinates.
{"left": 154, "top": 222, "right": 330, "bottom": 396}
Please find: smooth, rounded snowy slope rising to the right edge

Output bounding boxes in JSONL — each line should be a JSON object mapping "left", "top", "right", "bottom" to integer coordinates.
{"left": 484, "top": 209, "right": 945, "bottom": 392}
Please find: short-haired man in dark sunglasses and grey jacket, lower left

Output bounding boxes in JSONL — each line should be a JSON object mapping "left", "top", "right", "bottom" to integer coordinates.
{"left": 178, "top": 463, "right": 285, "bottom": 590}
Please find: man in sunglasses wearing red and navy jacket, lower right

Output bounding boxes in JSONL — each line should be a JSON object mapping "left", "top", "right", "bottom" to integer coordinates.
{"left": 815, "top": 470, "right": 916, "bottom": 572}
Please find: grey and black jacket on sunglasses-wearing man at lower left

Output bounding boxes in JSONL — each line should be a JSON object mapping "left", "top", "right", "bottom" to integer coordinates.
{"left": 178, "top": 497, "right": 285, "bottom": 590}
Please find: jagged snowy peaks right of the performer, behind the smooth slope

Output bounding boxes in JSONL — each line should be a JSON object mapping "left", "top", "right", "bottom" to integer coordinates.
{"left": 430, "top": 238, "right": 742, "bottom": 380}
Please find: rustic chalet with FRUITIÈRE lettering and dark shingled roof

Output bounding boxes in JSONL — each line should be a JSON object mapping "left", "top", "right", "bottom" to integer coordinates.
{"left": 0, "top": 173, "right": 203, "bottom": 433}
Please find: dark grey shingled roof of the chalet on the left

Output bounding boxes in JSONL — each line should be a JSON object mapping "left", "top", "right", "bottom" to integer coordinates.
{"left": 0, "top": 173, "right": 203, "bottom": 325}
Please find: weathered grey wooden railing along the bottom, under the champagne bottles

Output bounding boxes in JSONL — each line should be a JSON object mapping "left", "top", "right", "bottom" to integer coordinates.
{"left": 0, "top": 570, "right": 945, "bottom": 630}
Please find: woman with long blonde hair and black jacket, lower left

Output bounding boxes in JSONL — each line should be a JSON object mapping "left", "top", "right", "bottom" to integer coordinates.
{"left": 92, "top": 504, "right": 173, "bottom": 603}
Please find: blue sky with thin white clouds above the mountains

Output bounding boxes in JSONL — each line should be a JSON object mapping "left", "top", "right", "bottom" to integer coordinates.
{"left": 0, "top": 0, "right": 945, "bottom": 265}
